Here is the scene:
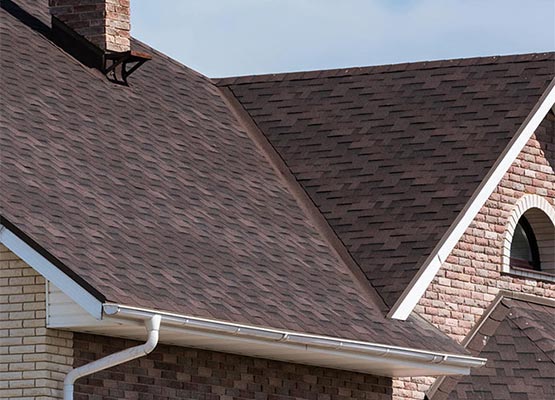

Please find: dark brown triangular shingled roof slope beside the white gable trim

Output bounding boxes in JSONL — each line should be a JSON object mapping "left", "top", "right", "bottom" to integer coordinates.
{"left": 218, "top": 53, "right": 555, "bottom": 306}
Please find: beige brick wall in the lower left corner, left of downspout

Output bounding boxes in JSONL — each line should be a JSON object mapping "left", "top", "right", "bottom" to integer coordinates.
{"left": 0, "top": 244, "right": 73, "bottom": 400}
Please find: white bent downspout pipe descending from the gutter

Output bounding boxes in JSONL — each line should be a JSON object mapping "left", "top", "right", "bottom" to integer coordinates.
{"left": 64, "top": 314, "right": 161, "bottom": 400}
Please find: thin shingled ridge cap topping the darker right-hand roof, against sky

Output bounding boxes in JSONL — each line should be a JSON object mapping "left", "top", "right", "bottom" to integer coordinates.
{"left": 212, "top": 51, "right": 555, "bottom": 86}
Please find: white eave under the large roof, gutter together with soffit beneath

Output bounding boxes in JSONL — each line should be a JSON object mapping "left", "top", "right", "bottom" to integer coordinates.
{"left": 99, "top": 303, "right": 486, "bottom": 376}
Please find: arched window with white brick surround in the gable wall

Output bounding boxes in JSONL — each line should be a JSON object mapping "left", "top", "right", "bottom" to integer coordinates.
{"left": 503, "top": 195, "right": 555, "bottom": 282}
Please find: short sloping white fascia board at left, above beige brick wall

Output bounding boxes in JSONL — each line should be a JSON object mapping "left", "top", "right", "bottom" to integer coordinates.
{"left": 0, "top": 225, "right": 102, "bottom": 320}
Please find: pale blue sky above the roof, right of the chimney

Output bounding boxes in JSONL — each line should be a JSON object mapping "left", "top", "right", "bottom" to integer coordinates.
{"left": 131, "top": 0, "right": 555, "bottom": 77}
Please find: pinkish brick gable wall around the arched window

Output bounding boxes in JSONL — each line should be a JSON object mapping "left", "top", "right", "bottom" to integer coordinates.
{"left": 393, "top": 114, "right": 555, "bottom": 400}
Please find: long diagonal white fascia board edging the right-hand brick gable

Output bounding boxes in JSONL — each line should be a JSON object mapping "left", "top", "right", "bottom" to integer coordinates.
{"left": 388, "top": 79, "right": 555, "bottom": 320}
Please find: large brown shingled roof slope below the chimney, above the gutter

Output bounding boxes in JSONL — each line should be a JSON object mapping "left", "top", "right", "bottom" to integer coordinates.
{"left": 0, "top": 0, "right": 463, "bottom": 352}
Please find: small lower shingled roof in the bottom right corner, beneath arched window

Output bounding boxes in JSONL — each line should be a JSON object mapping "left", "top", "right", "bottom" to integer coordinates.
{"left": 431, "top": 298, "right": 555, "bottom": 400}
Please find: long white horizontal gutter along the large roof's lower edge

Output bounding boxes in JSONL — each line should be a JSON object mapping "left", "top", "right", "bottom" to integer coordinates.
{"left": 104, "top": 304, "right": 486, "bottom": 374}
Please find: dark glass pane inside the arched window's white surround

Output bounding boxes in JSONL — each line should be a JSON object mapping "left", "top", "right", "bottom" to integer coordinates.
{"left": 511, "top": 217, "right": 540, "bottom": 270}
